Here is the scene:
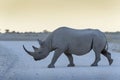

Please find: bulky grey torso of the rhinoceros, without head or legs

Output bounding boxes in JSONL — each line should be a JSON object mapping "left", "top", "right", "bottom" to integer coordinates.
{"left": 46, "top": 27, "right": 106, "bottom": 55}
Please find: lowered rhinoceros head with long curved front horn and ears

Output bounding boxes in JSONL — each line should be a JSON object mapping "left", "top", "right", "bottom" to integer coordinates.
{"left": 23, "top": 40, "right": 49, "bottom": 61}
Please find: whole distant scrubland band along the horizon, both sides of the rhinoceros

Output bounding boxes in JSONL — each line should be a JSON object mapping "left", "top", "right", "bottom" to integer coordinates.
{"left": 0, "top": 30, "right": 120, "bottom": 42}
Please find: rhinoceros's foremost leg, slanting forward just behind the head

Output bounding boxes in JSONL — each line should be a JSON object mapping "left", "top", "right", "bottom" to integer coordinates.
{"left": 48, "top": 49, "right": 63, "bottom": 68}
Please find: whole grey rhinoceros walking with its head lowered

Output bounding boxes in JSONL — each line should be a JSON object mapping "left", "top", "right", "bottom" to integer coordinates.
{"left": 23, "top": 27, "right": 113, "bottom": 68}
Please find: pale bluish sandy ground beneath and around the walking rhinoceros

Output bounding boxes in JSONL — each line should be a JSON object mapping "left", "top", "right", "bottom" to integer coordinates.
{"left": 0, "top": 41, "right": 120, "bottom": 80}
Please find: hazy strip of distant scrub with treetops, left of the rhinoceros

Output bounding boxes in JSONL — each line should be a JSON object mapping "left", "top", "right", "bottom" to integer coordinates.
{"left": 0, "top": 29, "right": 50, "bottom": 41}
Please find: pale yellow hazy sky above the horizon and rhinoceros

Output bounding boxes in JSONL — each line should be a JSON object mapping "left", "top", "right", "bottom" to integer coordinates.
{"left": 0, "top": 0, "right": 120, "bottom": 32}
